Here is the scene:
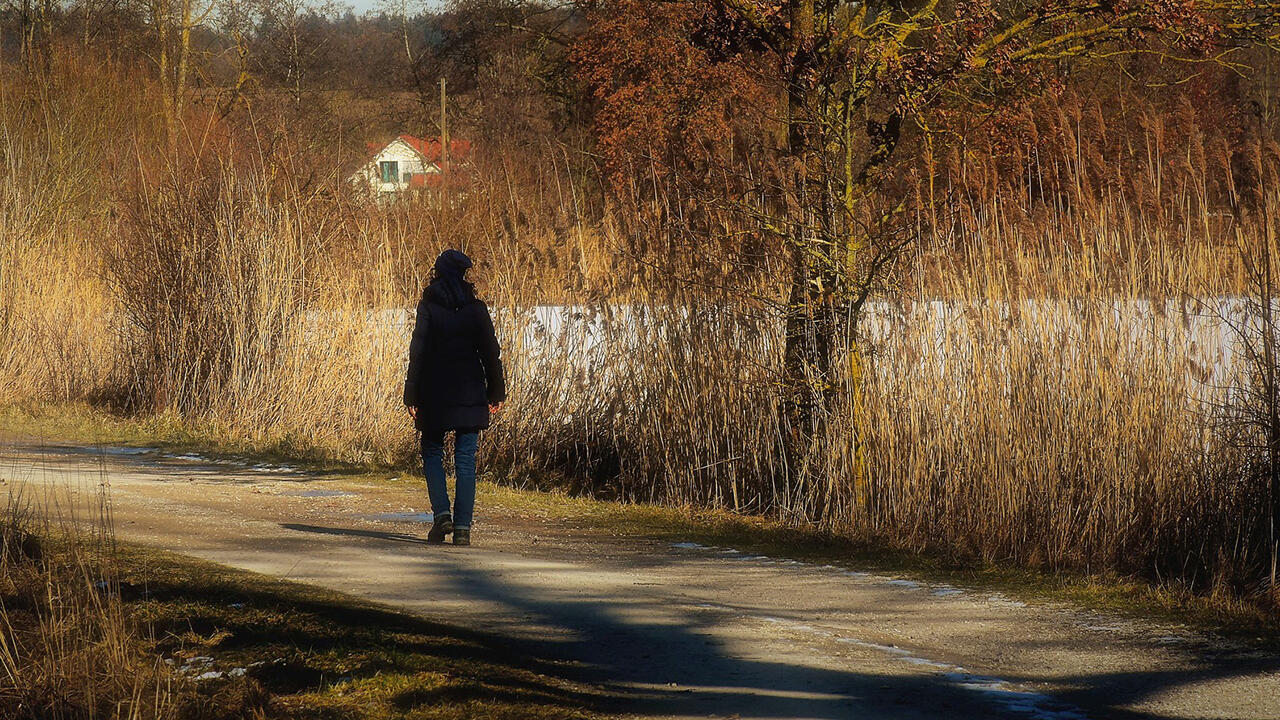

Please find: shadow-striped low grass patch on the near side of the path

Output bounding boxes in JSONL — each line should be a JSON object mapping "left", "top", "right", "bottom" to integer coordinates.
{"left": 119, "top": 546, "right": 598, "bottom": 720}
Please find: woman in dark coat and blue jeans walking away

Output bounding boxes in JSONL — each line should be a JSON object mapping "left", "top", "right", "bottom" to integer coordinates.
{"left": 404, "top": 250, "right": 507, "bottom": 544}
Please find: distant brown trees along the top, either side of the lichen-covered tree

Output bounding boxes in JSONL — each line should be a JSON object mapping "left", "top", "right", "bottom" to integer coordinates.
{"left": 0, "top": 0, "right": 1280, "bottom": 200}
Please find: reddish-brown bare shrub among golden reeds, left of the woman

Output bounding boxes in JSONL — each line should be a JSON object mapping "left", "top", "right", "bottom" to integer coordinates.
{"left": 106, "top": 155, "right": 316, "bottom": 413}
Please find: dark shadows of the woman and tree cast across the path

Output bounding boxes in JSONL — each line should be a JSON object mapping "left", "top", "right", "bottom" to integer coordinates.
{"left": 272, "top": 524, "right": 1280, "bottom": 720}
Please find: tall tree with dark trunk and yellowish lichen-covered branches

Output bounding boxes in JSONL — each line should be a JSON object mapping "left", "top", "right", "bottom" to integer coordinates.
{"left": 579, "top": 0, "right": 1280, "bottom": 515}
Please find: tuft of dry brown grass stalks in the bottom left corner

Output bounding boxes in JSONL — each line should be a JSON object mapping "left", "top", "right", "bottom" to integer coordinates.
{"left": 0, "top": 484, "right": 183, "bottom": 720}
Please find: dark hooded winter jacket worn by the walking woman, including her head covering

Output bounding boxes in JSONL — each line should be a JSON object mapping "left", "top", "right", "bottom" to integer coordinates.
{"left": 404, "top": 250, "right": 507, "bottom": 433}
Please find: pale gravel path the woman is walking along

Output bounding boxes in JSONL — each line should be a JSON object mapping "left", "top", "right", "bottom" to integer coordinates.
{"left": 0, "top": 445, "right": 1280, "bottom": 720}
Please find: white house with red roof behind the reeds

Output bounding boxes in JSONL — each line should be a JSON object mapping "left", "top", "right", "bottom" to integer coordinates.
{"left": 349, "top": 135, "right": 471, "bottom": 195}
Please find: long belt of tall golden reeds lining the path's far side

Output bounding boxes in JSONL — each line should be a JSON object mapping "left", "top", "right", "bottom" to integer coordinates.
{"left": 0, "top": 58, "right": 1280, "bottom": 603}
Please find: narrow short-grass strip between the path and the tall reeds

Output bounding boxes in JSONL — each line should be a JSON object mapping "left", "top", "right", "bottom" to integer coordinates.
{"left": 10, "top": 397, "right": 1280, "bottom": 647}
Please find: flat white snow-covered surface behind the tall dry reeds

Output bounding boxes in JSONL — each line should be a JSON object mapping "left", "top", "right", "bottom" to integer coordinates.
{"left": 345, "top": 296, "right": 1264, "bottom": 398}
